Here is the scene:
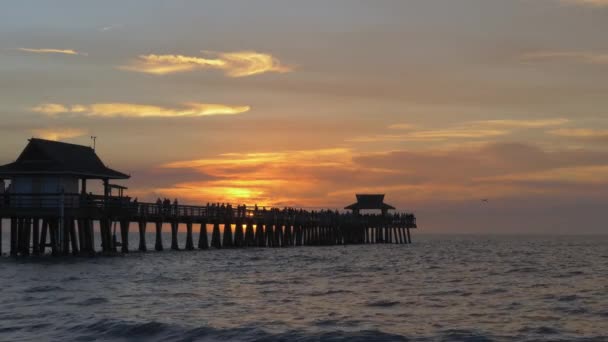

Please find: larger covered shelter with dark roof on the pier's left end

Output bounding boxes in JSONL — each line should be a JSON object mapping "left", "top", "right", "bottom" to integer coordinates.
{"left": 0, "top": 138, "right": 130, "bottom": 207}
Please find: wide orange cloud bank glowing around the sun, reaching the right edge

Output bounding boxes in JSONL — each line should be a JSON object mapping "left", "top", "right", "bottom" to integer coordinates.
{"left": 140, "top": 143, "right": 608, "bottom": 212}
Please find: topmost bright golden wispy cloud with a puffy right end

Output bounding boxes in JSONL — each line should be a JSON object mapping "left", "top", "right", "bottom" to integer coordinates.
{"left": 120, "top": 51, "right": 293, "bottom": 77}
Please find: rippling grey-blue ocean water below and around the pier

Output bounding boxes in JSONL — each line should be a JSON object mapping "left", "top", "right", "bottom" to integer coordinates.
{"left": 0, "top": 234, "right": 608, "bottom": 341}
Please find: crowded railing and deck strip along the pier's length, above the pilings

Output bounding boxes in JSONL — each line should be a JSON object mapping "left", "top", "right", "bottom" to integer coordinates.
{"left": 0, "top": 193, "right": 416, "bottom": 228}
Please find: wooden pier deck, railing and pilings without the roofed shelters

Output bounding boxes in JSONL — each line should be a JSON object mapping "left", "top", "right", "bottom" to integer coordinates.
{"left": 0, "top": 194, "right": 416, "bottom": 256}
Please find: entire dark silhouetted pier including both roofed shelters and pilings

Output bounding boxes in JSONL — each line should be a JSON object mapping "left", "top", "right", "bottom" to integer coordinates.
{"left": 0, "top": 138, "right": 417, "bottom": 256}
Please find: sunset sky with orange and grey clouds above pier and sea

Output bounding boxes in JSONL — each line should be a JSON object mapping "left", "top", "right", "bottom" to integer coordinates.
{"left": 0, "top": 0, "right": 608, "bottom": 234}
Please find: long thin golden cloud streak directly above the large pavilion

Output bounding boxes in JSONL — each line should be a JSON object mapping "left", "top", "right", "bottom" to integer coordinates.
{"left": 32, "top": 103, "right": 251, "bottom": 118}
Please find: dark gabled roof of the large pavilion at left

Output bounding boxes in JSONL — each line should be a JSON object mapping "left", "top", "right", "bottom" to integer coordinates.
{"left": 0, "top": 138, "right": 130, "bottom": 179}
